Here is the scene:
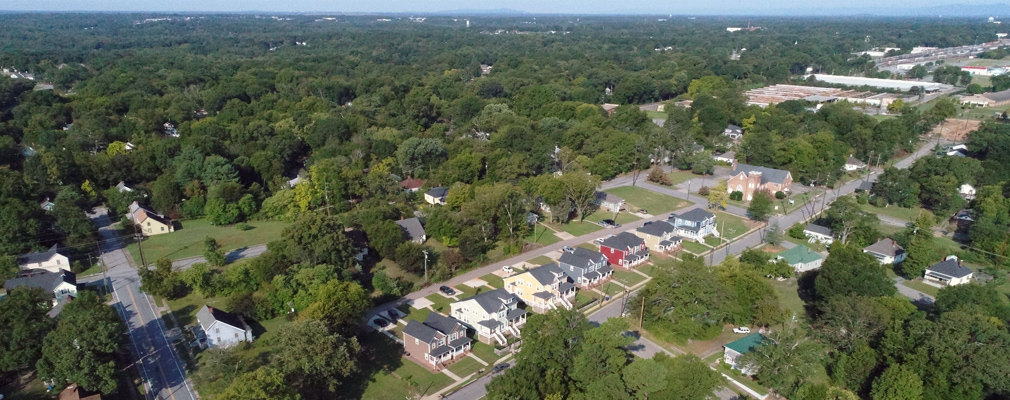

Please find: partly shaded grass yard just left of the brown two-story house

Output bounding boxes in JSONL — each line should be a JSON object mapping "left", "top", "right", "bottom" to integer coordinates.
{"left": 361, "top": 332, "right": 452, "bottom": 399}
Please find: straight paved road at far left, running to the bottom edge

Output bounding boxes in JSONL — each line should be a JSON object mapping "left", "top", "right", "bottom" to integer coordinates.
{"left": 88, "top": 208, "right": 197, "bottom": 400}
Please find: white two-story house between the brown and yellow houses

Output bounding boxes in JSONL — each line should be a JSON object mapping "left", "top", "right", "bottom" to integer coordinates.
{"left": 449, "top": 289, "right": 526, "bottom": 344}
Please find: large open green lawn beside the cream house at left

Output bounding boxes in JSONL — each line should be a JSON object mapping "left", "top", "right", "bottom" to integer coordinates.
{"left": 126, "top": 219, "right": 291, "bottom": 264}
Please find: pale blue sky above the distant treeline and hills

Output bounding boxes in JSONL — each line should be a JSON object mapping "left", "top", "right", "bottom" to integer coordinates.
{"left": 0, "top": 0, "right": 1006, "bottom": 14}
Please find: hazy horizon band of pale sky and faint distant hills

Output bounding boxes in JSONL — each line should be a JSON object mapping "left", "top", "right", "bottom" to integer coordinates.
{"left": 0, "top": 0, "right": 1010, "bottom": 16}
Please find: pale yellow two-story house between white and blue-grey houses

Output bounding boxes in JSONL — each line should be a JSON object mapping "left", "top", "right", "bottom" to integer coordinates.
{"left": 504, "top": 263, "right": 576, "bottom": 313}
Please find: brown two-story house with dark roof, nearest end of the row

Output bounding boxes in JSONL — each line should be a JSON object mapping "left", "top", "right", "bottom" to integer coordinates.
{"left": 403, "top": 312, "right": 473, "bottom": 371}
